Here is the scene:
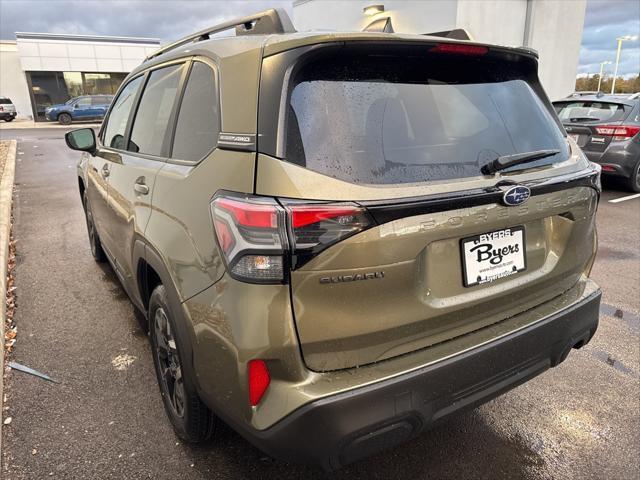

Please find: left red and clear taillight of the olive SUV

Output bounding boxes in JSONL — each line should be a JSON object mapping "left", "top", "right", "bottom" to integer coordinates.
{"left": 211, "top": 194, "right": 373, "bottom": 283}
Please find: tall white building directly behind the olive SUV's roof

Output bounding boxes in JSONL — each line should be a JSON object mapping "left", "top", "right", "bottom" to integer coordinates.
{"left": 293, "top": 0, "right": 587, "bottom": 100}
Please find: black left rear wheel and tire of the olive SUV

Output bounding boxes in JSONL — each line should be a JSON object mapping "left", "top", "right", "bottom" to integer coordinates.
{"left": 149, "top": 285, "right": 216, "bottom": 443}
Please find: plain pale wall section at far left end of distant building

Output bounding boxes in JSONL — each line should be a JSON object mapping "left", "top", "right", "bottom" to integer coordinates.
{"left": 0, "top": 41, "right": 33, "bottom": 118}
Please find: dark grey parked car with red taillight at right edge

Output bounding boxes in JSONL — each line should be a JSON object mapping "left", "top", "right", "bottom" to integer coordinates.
{"left": 553, "top": 94, "right": 640, "bottom": 192}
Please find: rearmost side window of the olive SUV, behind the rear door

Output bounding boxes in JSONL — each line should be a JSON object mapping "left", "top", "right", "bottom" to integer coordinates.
{"left": 171, "top": 62, "right": 220, "bottom": 161}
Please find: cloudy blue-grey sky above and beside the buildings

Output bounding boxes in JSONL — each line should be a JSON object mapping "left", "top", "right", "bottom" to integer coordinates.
{"left": 0, "top": 0, "right": 640, "bottom": 77}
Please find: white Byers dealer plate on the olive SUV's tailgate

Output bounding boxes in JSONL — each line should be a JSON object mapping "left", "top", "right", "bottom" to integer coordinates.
{"left": 460, "top": 226, "right": 527, "bottom": 287}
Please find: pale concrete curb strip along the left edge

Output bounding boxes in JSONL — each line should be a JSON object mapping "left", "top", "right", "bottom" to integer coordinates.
{"left": 0, "top": 140, "right": 18, "bottom": 454}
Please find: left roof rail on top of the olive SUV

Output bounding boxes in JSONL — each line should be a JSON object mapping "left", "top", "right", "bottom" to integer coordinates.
{"left": 145, "top": 8, "right": 296, "bottom": 61}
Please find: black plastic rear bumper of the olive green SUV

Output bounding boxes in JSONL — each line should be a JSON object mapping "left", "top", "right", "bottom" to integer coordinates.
{"left": 235, "top": 291, "right": 601, "bottom": 469}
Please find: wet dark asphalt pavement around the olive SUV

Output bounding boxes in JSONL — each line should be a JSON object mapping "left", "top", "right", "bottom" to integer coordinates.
{"left": 0, "top": 129, "right": 640, "bottom": 480}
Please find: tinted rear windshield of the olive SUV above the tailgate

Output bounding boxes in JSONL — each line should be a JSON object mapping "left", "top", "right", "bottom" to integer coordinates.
{"left": 285, "top": 49, "right": 568, "bottom": 184}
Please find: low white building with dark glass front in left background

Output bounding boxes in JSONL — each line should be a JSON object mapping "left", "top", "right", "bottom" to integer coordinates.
{"left": 0, "top": 32, "right": 160, "bottom": 120}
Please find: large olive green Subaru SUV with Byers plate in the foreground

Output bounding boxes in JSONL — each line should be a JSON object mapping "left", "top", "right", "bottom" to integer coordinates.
{"left": 66, "top": 10, "right": 600, "bottom": 469}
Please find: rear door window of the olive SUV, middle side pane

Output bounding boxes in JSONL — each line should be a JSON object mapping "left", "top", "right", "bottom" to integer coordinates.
{"left": 127, "top": 65, "right": 182, "bottom": 155}
